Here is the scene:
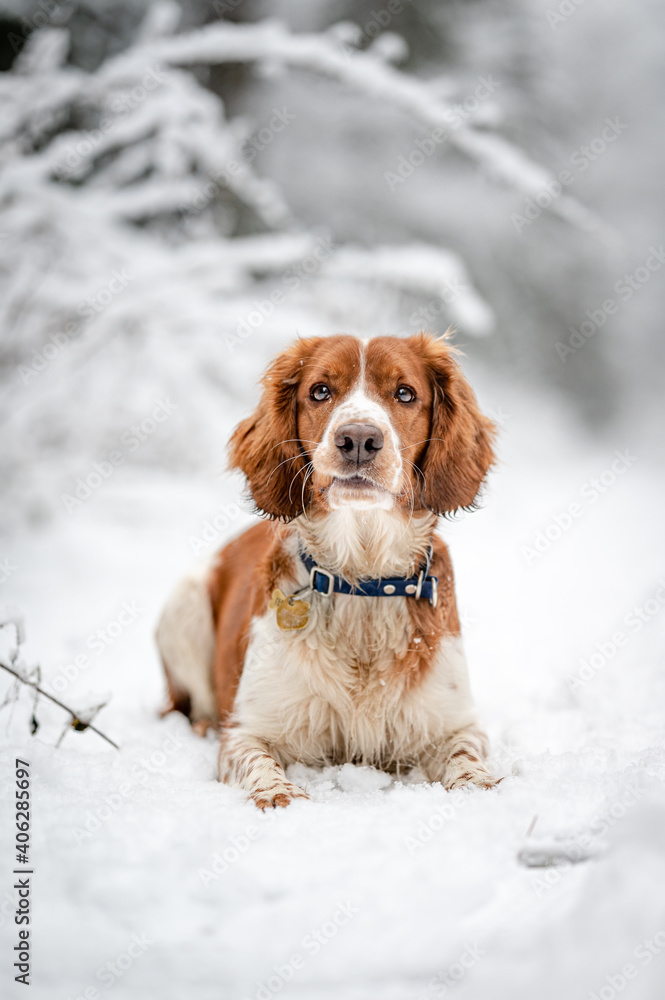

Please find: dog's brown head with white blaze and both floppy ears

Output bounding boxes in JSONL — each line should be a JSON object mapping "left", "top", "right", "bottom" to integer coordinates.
{"left": 231, "top": 333, "right": 495, "bottom": 521}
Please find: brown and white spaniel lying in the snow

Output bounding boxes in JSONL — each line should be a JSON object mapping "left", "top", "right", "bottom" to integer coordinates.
{"left": 157, "top": 334, "right": 496, "bottom": 808}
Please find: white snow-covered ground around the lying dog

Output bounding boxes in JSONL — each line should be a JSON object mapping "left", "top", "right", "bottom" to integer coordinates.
{"left": 0, "top": 379, "right": 665, "bottom": 1000}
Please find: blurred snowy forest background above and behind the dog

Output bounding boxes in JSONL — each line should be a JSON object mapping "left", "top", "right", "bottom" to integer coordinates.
{"left": 0, "top": 0, "right": 665, "bottom": 519}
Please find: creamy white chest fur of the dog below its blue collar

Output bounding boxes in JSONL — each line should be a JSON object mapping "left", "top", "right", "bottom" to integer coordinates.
{"left": 236, "top": 552, "right": 474, "bottom": 768}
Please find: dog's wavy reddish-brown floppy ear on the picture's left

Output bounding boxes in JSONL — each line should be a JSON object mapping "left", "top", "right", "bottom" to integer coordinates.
{"left": 229, "top": 337, "right": 320, "bottom": 521}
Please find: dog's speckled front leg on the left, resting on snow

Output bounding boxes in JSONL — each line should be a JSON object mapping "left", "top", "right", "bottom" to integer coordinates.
{"left": 219, "top": 727, "right": 309, "bottom": 809}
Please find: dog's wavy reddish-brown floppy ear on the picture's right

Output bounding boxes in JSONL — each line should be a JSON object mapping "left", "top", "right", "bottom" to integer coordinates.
{"left": 418, "top": 334, "right": 496, "bottom": 514}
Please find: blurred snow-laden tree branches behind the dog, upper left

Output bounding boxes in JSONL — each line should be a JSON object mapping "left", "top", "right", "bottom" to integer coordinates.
{"left": 0, "top": 2, "right": 603, "bottom": 516}
